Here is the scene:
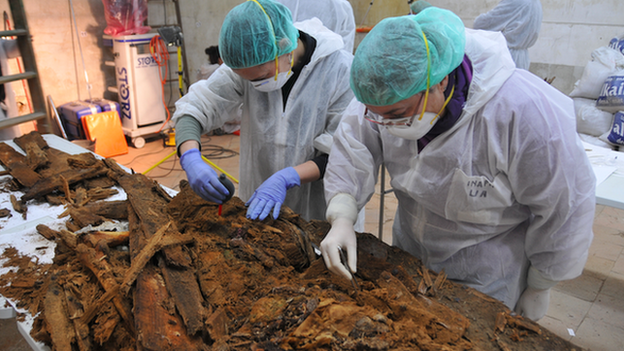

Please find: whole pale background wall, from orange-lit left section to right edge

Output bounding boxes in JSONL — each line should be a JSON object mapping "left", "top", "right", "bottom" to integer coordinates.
{"left": 0, "top": 0, "right": 624, "bottom": 136}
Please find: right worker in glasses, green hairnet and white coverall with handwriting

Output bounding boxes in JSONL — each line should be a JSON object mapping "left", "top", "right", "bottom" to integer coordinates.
{"left": 320, "top": 7, "right": 596, "bottom": 320}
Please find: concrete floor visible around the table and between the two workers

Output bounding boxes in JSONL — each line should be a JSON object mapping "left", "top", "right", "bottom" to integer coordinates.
{"left": 0, "top": 135, "right": 624, "bottom": 351}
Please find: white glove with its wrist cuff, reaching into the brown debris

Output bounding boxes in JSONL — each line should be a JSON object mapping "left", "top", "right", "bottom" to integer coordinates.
{"left": 321, "top": 193, "right": 358, "bottom": 280}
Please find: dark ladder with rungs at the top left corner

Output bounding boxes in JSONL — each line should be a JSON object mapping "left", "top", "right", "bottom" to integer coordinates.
{"left": 0, "top": 0, "right": 52, "bottom": 133}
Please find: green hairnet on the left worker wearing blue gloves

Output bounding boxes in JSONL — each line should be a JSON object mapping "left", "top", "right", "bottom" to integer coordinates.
{"left": 219, "top": 0, "right": 299, "bottom": 69}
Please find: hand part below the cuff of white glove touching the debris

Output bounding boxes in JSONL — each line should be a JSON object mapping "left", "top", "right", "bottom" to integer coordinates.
{"left": 321, "top": 217, "right": 357, "bottom": 280}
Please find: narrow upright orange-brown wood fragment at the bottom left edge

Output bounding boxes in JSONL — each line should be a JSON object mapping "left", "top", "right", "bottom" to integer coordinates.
{"left": 43, "top": 276, "right": 76, "bottom": 351}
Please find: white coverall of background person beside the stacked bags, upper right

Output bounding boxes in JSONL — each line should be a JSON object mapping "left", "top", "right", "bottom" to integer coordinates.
{"left": 473, "top": 0, "right": 542, "bottom": 70}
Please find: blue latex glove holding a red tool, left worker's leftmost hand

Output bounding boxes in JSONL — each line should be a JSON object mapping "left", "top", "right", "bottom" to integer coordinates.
{"left": 180, "top": 149, "right": 230, "bottom": 204}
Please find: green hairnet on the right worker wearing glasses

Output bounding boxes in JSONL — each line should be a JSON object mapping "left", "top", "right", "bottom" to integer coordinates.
{"left": 351, "top": 6, "right": 466, "bottom": 106}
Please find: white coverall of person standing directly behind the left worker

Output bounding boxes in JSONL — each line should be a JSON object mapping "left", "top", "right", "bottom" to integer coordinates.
{"left": 277, "top": 0, "right": 355, "bottom": 53}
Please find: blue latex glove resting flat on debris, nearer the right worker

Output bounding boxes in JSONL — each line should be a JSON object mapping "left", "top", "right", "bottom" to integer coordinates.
{"left": 245, "top": 167, "right": 301, "bottom": 220}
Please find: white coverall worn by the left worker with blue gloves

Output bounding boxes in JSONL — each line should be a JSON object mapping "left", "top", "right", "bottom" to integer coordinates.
{"left": 173, "top": 18, "right": 353, "bottom": 220}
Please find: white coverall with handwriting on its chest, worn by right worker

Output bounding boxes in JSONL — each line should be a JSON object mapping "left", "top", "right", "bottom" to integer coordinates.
{"left": 324, "top": 29, "right": 596, "bottom": 309}
